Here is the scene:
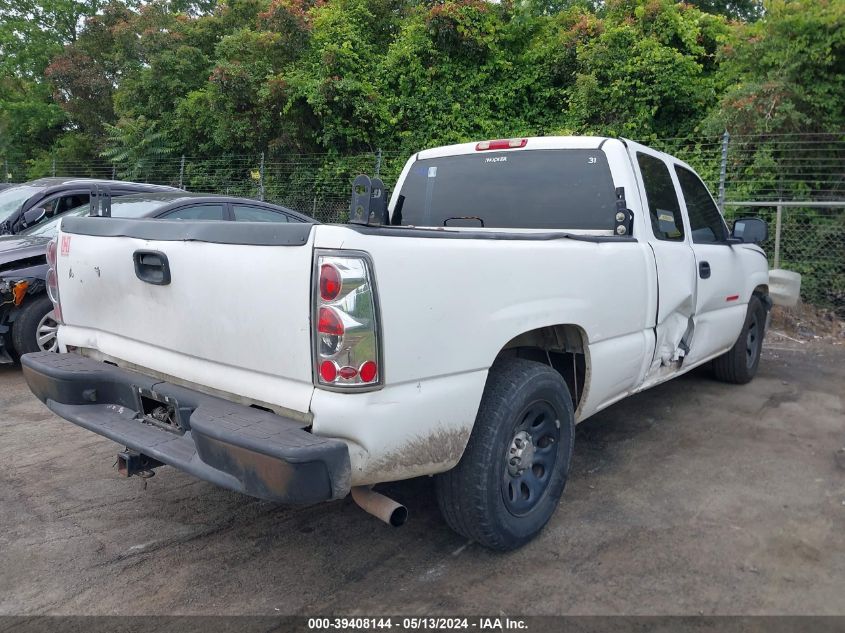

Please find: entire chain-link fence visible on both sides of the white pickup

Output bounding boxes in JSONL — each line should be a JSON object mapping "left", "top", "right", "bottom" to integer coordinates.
{"left": 5, "top": 132, "right": 845, "bottom": 315}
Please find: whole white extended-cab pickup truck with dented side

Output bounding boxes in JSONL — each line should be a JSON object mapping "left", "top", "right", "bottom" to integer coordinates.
{"left": 23, "top": 137, "right": 771, "bottom": 549}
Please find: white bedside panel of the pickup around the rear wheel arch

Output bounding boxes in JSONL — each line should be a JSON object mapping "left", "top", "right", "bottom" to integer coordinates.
{"left": 311, "top": 225, "right": 656, "bottom": 483}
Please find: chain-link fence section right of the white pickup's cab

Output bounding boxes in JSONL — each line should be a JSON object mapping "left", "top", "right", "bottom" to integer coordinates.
{"left": 651, "top": 132, "right": 845, "bottom": 317}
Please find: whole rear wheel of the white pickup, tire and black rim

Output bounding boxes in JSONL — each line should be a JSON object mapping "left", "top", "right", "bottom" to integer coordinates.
{"left": 435, "top": 358, "right": 575, "bottom": 550}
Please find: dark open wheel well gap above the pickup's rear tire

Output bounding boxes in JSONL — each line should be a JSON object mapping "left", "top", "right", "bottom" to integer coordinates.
{"left": 496, "top": 324, "right": 590, "bottom": 410}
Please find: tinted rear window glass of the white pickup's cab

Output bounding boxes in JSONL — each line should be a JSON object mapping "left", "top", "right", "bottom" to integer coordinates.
{"left": 392, "top": 149, "right": 616, "bottom": 230}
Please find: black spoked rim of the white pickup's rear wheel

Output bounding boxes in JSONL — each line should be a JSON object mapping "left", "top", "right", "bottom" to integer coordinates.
{"left": 502, "top": 400, "right": 560, "bottom": 516}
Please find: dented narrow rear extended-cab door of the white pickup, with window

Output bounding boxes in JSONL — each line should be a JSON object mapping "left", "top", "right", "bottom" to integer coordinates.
{"left": 630, "top": 144, "right": 696, "bottom": 380}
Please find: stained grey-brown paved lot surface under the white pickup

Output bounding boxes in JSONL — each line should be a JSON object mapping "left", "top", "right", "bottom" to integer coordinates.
{"left": 0, "top": 341, "right": 845, "bottom": 615}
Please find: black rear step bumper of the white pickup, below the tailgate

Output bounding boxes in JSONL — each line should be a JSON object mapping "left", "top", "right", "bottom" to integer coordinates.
{"left": 21, "top": 352, "right": 350, "bottom": 504}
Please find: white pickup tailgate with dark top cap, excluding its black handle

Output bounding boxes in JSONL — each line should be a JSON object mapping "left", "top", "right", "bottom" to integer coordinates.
{"left": 57, "top": 218, "right": 313, "bottom": 412}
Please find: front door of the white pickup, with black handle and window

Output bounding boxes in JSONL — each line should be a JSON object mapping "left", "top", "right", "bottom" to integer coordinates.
{"left": 672, "top": 163, "right": 746, "bottom": 364}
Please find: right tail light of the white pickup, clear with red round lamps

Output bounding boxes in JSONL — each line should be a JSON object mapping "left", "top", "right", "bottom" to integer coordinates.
{"left": 312, "top": 251, "right": 384, "bottom": 391}
